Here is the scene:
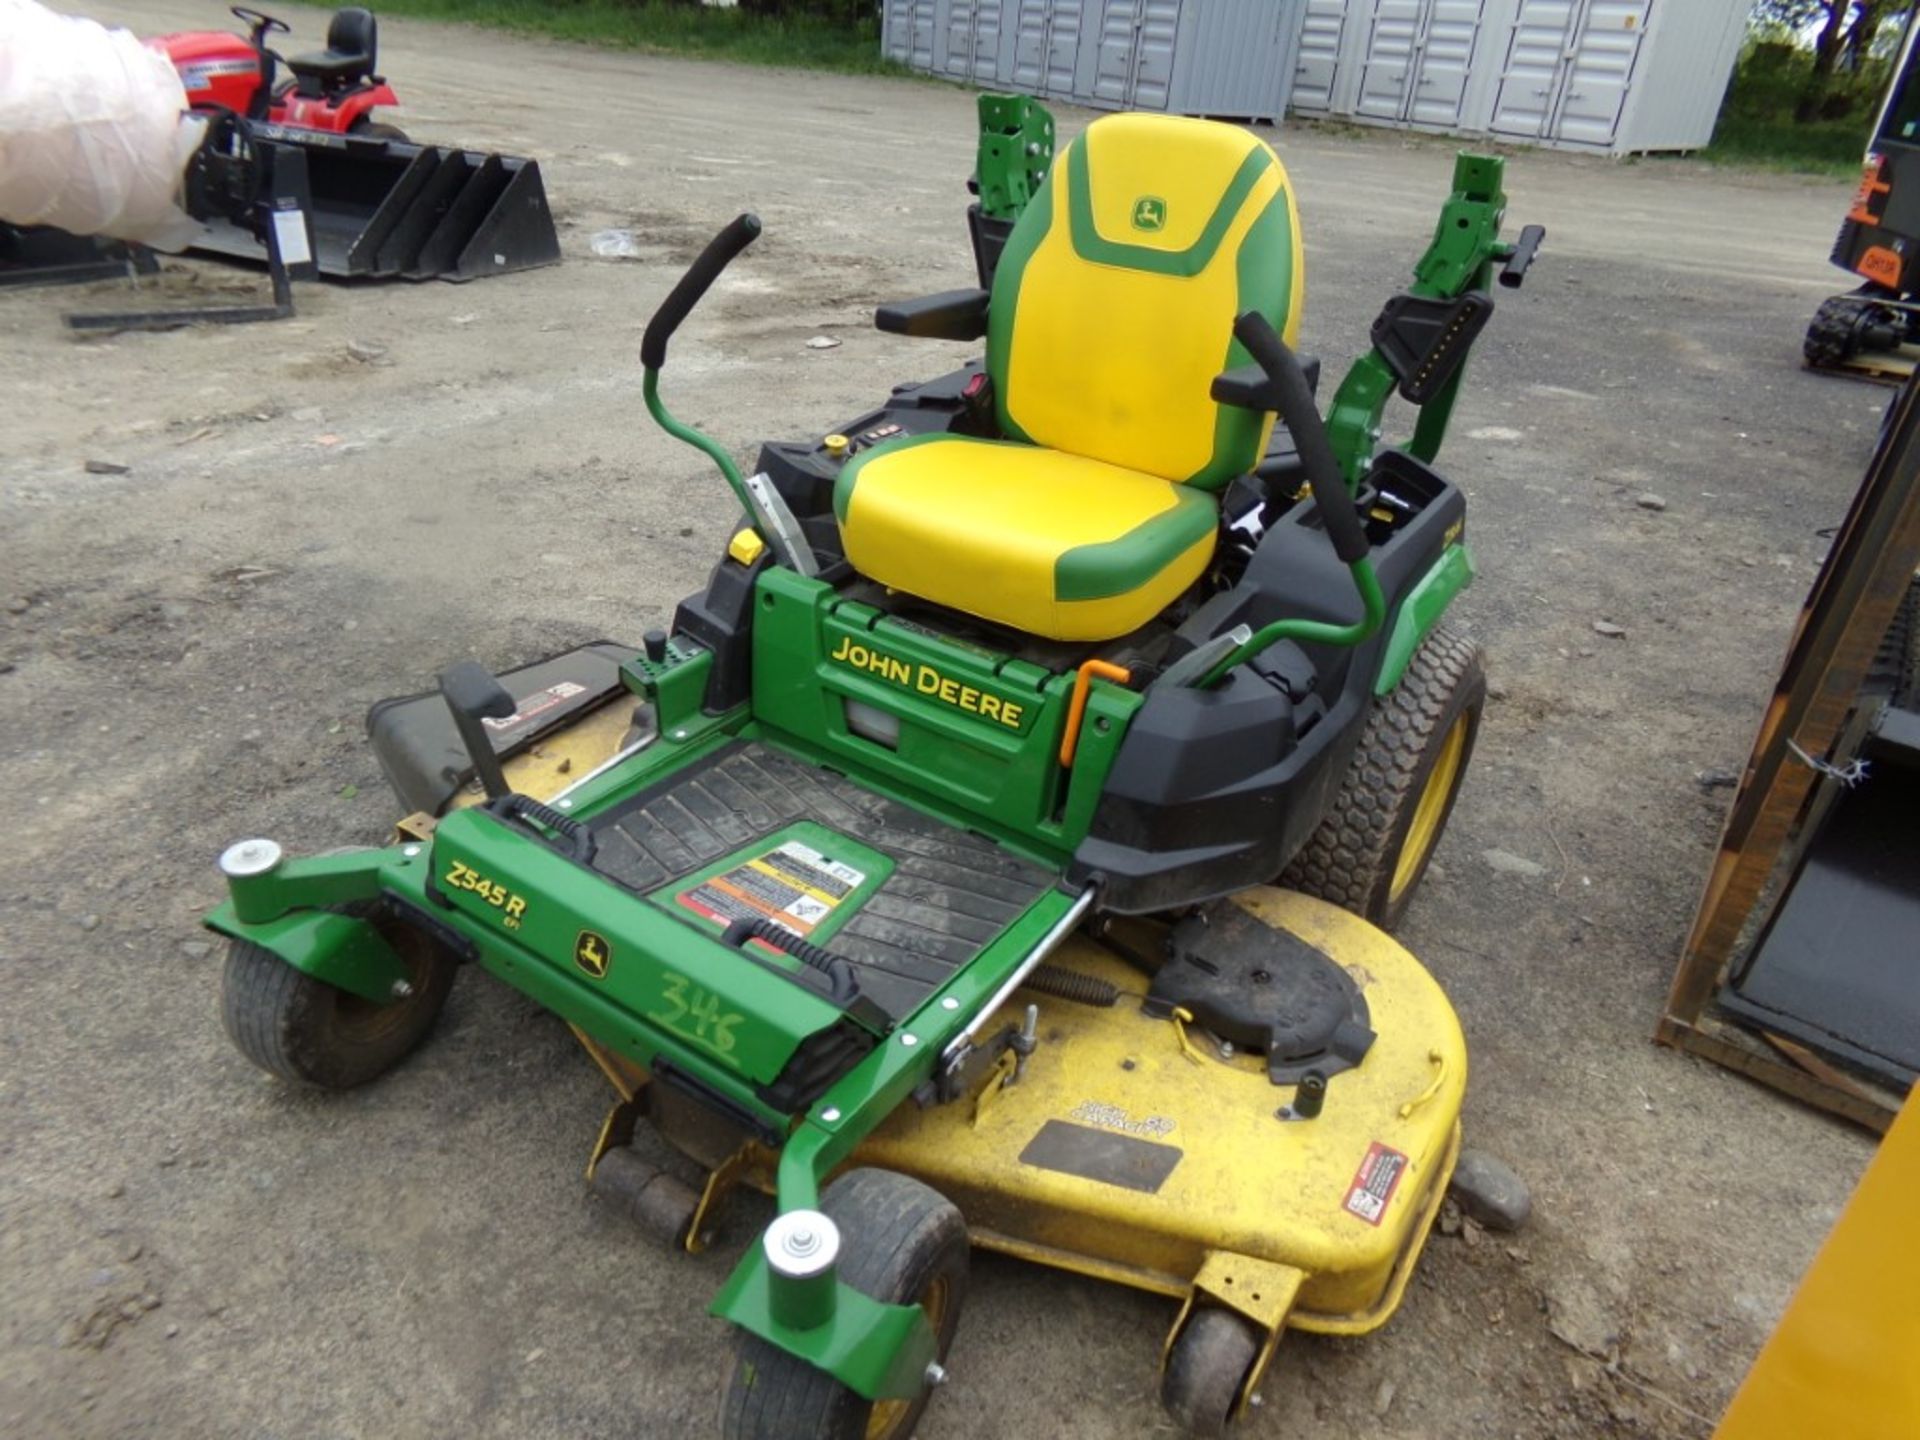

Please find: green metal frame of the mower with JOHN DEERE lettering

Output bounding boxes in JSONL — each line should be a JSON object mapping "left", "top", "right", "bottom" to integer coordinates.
{"left": 205, "top": 96, "right": 1542, "bottom": 1436}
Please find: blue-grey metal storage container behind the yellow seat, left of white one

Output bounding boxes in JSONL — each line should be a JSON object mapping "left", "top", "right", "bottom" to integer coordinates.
{"left": 881, "top": 0, "right": 1306, "bottom": 121}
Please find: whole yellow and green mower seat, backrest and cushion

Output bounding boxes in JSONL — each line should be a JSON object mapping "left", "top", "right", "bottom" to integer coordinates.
{"left": 833, "top": 115, "right": 1304, "bottom": 641}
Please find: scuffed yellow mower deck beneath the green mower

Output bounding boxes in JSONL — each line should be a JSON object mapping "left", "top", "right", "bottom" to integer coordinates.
{"left": 441, "top": 707, "right": 1467, "bottom": 1405}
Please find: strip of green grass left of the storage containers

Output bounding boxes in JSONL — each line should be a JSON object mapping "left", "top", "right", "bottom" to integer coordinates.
{"left": 376, "top": 0, "right": 908, "bottom": 75}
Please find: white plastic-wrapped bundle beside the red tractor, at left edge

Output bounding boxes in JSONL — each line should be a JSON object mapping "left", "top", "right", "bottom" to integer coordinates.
{"left": 0, "top": 0, "right": 205, "bottom": 250}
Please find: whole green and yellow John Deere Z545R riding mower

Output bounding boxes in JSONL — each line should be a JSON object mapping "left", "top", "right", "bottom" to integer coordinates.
{"left": 207, "top": 98, "right": 1540, "bottom": 1440}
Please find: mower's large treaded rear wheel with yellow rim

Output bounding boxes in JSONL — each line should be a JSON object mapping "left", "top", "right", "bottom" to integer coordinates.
{"left": 1279, "top": 626, "right": 1486, "bottom": 929}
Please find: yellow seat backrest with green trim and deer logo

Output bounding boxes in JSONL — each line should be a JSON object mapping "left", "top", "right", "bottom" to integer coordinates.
{"left": 987, "top": 115, "right": 1304, "bottom": 490}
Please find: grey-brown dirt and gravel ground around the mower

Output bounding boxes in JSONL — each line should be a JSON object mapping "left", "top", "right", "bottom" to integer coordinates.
{"left": 0, "top": 0, "right": 1885, "bottom": 1440}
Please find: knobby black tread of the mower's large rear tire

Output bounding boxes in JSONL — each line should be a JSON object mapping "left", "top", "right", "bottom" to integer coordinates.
{"left": 1281, "top": 624, "right": 1484, "bottom": 920}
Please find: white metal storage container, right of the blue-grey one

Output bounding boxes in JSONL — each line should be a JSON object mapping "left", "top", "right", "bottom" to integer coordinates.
{"left": 1294, "top": 0, "right": 1751, "bottom": 156}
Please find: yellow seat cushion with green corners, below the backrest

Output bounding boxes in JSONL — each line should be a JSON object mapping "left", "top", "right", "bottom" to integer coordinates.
{"left": 833, "top": 434, "right": 1219, "bottom": 639}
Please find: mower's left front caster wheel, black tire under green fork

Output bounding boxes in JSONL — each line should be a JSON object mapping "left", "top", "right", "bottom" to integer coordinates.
{"left": 221, "top": 916, "right": 459, "bottom": 1091}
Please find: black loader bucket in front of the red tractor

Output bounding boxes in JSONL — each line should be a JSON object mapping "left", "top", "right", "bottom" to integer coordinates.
{"left": 194, "top": 125, "right": 561, "bottom": 280}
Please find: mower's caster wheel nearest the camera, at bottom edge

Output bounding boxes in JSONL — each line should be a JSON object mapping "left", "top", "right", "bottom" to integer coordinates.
{"left": 720, "top": 1169, "right": 968, "bottom": 1440}
